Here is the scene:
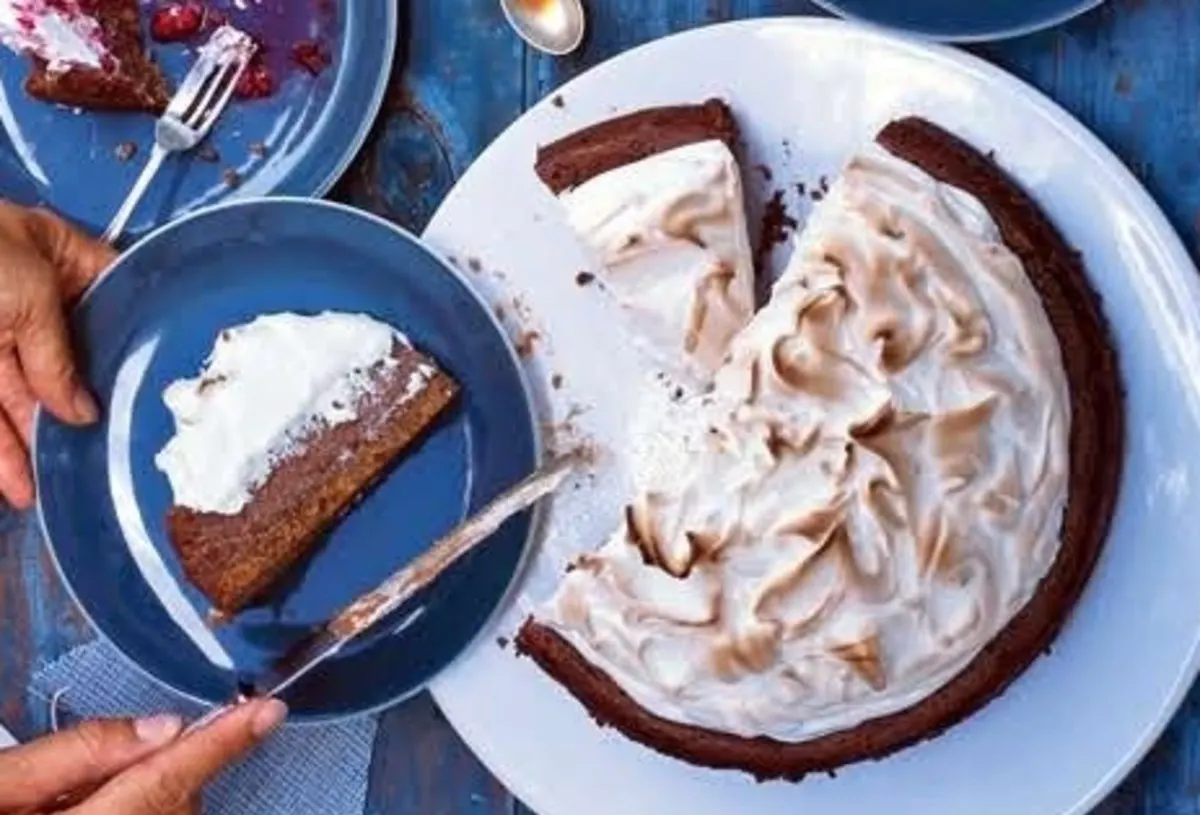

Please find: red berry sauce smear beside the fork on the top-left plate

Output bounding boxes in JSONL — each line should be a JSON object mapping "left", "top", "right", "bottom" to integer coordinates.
{"left": 150, "top": 0, "right": 338, "bottom": 101}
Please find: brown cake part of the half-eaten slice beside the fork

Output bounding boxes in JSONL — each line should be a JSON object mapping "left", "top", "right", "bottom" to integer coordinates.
{"left": 25, "top": 0, "right": 170, "bottom": 114}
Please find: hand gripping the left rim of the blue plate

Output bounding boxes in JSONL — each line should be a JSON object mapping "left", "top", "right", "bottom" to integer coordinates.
{"left": 0, "top": 202, "right": 115, "bottom": 509}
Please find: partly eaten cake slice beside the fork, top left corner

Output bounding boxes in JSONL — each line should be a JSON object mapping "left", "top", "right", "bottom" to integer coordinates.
{"left": 0, "top": 0, "right": 170, "bottom": 114}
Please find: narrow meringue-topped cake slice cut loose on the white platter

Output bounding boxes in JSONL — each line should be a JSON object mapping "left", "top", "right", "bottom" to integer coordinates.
{"left": 536, "top": 100, "right": 754, "bottom": 382}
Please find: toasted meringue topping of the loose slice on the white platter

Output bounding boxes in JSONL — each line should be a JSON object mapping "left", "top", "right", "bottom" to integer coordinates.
{"left": 559, "top": 140, "right": 754, "bottom": 383}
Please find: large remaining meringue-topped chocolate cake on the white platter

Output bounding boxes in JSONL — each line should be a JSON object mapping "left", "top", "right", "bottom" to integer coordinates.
{"left": 517, "top": 119, "right": 1123, "bottom": 779}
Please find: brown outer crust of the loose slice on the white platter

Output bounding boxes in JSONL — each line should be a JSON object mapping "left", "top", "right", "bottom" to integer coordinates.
{"left": 534, "top": 100, "right": 738, "bottom": 196}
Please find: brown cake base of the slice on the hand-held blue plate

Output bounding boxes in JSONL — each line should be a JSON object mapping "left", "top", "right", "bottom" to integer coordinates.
{"left": 167, "top": 344, "right": 458, "bottom": 617}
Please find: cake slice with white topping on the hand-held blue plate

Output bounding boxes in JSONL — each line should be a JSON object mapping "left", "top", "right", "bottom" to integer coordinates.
{"left": 155, "top": 312, "right": 457, "bottom": 616}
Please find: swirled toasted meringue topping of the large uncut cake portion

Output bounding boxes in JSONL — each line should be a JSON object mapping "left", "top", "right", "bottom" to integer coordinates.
{"left": 538, "top": 141, "right": 1069, "bottom": 741}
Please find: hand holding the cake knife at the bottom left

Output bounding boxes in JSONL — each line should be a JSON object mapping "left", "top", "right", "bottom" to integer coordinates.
{"left": 0, "top": 700, "right": 287, "bottom": 815}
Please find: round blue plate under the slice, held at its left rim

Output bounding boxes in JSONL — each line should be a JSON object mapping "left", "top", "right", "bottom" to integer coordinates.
{"left": 34, "top": 199, "right": 538, "bottom": 720}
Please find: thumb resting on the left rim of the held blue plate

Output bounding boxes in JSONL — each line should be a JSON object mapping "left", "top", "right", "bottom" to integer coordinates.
{"left": 14, "top": 266, "right": 98, "bottom": 434}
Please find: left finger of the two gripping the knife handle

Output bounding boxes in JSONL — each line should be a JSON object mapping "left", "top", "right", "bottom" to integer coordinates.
{"left": 0, "top": 715, "right": 182, "bottom": 813}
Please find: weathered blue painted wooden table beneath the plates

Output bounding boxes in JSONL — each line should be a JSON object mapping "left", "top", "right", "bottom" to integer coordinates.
{"left": 0, "top": 0, "right": 1200, "bottom": 815}
